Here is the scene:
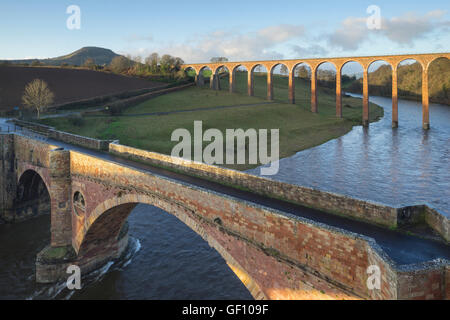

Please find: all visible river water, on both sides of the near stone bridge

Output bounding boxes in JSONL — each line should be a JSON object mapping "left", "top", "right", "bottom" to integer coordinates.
{"left": 0, "top": 97, "right": 450, "bottom": 299}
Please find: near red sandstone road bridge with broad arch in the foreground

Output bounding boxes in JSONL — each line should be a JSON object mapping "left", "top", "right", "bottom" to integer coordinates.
{"left": 0, "top": 134, "right": 450, "bottom": 299}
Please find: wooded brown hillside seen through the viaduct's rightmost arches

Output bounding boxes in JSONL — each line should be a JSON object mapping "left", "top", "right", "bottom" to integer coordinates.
{"left": 345, "top": 59, "right": 450, "bottom": 105}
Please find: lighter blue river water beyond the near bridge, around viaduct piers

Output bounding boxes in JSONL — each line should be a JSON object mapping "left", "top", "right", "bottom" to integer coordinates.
{"left": 248, "top": 95, "right": 450, "bottom": 215}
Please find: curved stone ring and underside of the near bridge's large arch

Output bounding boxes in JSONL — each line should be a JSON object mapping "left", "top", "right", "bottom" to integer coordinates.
{"left": 74, "top": 194, "right": 267, "bottom": 299}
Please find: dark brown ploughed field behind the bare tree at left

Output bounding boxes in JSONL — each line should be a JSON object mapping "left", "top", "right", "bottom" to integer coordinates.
{"left": 0, "top": 66, "right": 161, "bottom": 111}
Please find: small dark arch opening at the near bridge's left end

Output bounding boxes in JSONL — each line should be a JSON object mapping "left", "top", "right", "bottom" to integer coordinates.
{"left": 15, "top": 169, "right": 51, "bottom": 219}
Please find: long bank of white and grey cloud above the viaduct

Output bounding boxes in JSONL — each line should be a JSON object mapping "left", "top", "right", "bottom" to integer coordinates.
{"left": 122, "top": 10, "right": 450, "bottom": 63}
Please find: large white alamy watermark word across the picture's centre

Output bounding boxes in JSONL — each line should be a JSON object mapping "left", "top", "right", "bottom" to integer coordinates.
{"left": 171, "top": 121, "right": 280, "bottom": 176}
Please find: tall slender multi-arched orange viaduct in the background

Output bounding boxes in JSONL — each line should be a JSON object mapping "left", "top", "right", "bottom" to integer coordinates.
{"left": 183, "top": 53, "right": 450, "bottom": 129}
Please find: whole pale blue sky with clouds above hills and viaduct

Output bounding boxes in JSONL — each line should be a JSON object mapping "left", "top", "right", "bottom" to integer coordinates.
{"left": 0, "top": 0, "right": 450, "bottom": 62}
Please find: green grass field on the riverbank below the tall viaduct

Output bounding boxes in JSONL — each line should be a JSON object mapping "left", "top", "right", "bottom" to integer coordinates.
{"left": 41, "top": 73, "right": 383, "bottom": 170}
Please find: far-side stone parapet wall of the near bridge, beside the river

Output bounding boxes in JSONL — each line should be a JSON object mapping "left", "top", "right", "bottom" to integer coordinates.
{"left": 109, "top": 143, "right": 450, "bottom": 241}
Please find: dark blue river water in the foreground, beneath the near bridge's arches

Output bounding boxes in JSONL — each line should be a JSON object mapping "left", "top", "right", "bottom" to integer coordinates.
{"left": 0, "top": 205, "right": 252, "bottom": 300}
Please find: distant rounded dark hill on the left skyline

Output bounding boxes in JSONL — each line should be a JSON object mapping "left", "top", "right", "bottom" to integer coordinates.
{"left": 0, "top": 47, "right": 119, "bottom": 66}
